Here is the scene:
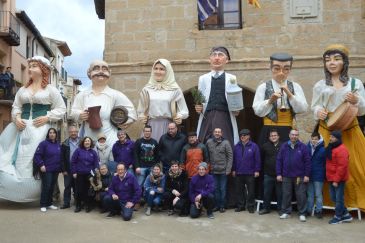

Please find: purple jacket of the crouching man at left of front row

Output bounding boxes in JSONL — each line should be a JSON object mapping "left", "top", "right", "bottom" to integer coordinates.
{"left": 108, "top": 172, "right": 142, "bottom": 204}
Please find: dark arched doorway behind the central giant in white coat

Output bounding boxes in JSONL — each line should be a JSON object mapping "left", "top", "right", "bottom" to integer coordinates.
{"left": 181, "top": 85, "right": 263, "bottom": 142}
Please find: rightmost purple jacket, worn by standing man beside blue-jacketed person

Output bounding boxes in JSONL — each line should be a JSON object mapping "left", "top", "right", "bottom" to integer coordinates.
{"left": 276, "top": 141, "right": 311, "bottom": 177}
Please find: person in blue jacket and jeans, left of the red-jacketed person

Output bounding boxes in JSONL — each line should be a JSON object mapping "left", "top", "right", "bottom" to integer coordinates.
{"left": 307, "top": 132, "right": 326, "bottom": 219}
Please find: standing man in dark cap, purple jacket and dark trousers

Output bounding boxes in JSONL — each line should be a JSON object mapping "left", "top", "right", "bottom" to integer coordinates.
{"left": 232, "top": 129, "right": 261, "bottom": 213}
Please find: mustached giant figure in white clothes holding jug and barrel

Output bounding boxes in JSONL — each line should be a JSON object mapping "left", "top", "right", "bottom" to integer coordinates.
{"left": 71, "top": 60, "right": 137, "bottom": 146}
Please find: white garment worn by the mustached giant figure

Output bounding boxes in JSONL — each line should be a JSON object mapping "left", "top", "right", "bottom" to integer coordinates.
{"left": 71, "top": 86, "right": 137, "bottom": 147}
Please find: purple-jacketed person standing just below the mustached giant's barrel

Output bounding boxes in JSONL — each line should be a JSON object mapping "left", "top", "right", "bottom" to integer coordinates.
{"left": 109, "top": 130, "right": 134, "bottom": 175}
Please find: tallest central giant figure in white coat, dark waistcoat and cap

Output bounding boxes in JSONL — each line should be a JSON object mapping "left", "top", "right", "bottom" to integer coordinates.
{"left": 195, "top": 46, "right": 239, "bottom": 148}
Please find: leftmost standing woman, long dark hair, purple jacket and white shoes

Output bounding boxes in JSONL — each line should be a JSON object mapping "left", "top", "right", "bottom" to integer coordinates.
{"left": 34, "top": 128, "right": 61, "bottom": 212}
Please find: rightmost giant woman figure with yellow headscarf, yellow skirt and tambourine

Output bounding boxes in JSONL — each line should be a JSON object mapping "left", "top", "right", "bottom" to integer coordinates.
{"left": 311, "top": 44, "right": 365, "bottom": 211}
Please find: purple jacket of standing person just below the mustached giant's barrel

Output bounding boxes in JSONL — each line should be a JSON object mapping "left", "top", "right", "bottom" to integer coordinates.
{"left": 112, "top": 139, "right": 134, "bottom": 168}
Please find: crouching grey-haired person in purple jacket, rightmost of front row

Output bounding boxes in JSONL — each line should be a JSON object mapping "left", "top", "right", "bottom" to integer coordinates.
{"left": 189, "top": 162, "right": 214, "bottom": 219}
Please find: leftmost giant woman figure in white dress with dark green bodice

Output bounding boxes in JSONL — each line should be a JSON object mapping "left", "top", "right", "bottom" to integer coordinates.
{"left": 0, "top": 56, "right": 66, "bottom": 202}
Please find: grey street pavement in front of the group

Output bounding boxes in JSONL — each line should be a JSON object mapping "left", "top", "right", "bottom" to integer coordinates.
{"left": 0, "top": 197, "right": 365, "bottom": 243}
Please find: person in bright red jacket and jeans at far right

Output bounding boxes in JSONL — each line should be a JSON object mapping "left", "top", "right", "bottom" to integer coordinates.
{"left": 326, "top": 131, "right": 352, "bottom": 224}
